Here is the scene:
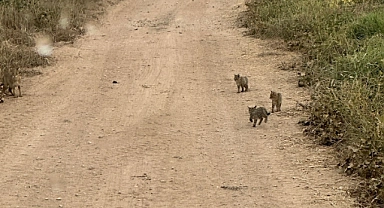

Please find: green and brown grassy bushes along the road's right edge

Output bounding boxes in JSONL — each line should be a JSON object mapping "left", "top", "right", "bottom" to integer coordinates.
{"left": 241, "top": 0, "right": 384, "bottom": 207}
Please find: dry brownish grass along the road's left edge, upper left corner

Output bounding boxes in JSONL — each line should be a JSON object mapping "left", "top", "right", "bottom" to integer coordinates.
{"left": 0, "top": 0, "right": 117, "bottom": 77}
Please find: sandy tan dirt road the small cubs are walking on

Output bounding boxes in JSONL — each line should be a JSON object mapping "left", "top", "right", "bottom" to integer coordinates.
{"left": 0, "top": 0, "right": 353, "bottom": 208}
